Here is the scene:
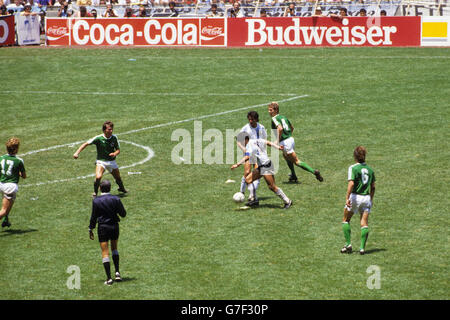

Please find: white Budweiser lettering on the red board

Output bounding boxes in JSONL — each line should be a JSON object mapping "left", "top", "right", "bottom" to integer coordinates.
{"left": 245, "top": 18, "right": 397, "bottom": 46}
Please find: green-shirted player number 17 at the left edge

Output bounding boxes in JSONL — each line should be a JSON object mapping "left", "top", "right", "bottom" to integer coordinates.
{"left": 0, "top": 138, "right": 27, "bottom": 227}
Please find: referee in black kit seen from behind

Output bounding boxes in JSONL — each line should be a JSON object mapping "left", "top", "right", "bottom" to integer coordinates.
{"left": 89, "top": 180, "right": 127, "bottom": 285}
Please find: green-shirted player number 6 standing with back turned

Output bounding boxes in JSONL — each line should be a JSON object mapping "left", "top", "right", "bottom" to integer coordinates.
{"left": 341, "top": 146, "right": 375, "bottom": 254}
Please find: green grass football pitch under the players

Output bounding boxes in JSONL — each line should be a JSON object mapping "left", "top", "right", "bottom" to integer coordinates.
{"left": 0, "top": 48, "right": 450, "bottom": 300}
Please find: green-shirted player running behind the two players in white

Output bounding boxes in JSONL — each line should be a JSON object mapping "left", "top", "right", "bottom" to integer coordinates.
{"left": 268, "top": 102, "right": 323, "bottom": 182}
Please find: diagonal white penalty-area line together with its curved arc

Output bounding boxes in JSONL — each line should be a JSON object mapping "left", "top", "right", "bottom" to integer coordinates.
{"left": 18, "top": 94, "right": 308, "bottom": 187}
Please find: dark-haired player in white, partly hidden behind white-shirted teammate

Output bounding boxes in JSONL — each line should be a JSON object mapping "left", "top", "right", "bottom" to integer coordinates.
{"left": 237, "top": 111, "right": 267, "bottom": 202}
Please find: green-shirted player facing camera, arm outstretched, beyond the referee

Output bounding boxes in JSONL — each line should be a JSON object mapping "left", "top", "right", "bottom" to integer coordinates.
{"left": 73, "top": 121, "right": 128, "bottom": 197}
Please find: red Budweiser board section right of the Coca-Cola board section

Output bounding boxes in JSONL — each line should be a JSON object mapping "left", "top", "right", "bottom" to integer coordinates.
{"left": 228, "top": 17, "right": 420, "bottom": 46}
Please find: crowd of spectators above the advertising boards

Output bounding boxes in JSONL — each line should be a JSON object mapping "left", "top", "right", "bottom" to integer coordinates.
{"left": 0, "top": 0, "right": 386, "bottom": 18}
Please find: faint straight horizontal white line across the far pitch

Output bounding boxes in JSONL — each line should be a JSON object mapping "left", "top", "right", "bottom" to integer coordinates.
{"left": 0, "top": 90, "right": 302, "bottom": 97}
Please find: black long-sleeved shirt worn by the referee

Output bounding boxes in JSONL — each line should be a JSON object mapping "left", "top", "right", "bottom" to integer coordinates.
{"left": 89, "top": 193, "right": 127, "bottom": 230}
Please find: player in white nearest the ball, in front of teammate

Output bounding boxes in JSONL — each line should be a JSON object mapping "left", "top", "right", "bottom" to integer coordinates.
{"left": 231, "top": 136, "right": 292, "bottom": 209}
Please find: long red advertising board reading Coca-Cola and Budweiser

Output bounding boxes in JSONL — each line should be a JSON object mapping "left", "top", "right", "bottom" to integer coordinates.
{"left": 45, "top": 17, "right": 421, "bottom": 47}
